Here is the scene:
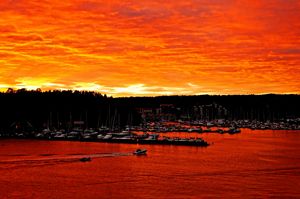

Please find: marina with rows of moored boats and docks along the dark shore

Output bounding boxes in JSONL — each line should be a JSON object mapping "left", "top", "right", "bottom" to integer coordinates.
{"left": 0, "top": 118, "right": 300, "bottom": 147}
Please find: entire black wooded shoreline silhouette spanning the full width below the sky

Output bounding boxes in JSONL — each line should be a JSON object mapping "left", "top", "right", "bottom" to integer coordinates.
{"left": 0, "top": 89, "right": 300, "bottom": 131}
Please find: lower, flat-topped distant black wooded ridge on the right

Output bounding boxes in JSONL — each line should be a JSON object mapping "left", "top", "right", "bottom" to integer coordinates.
{"left": 115, "top": 94, "right": 300, "bottom": 121}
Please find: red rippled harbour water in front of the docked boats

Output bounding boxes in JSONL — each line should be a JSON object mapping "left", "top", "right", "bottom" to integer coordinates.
{"left": 0, "top": 130, "right": 300, "bottom": 199}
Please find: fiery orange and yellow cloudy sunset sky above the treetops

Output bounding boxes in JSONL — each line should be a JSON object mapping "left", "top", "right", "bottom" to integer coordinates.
{"left": 0, "top": 0, "right": 300, "bottom": 96}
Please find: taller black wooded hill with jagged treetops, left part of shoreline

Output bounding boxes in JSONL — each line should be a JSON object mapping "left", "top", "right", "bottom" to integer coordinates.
{"left": 0, "top": 89, "right": 140, "bottom": 130}
